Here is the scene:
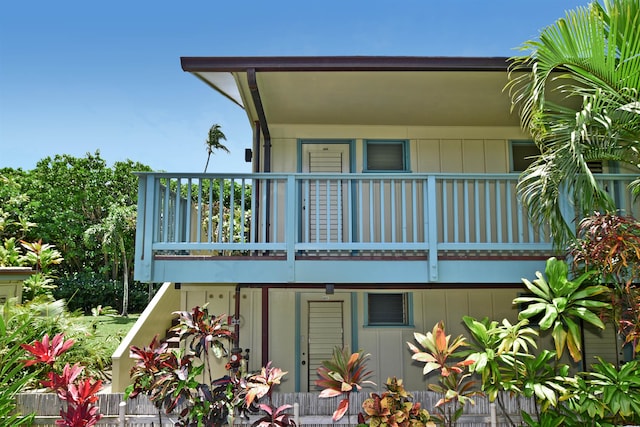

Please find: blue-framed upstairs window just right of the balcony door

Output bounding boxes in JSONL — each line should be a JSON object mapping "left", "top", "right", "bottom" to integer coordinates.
{"left": 364, "top": 140, "right": 409, "bottom": 172}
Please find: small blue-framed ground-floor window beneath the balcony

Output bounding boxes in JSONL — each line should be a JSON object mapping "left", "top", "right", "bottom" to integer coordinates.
{"left": 365, "top": 292, "right": 412, "bottom": 326}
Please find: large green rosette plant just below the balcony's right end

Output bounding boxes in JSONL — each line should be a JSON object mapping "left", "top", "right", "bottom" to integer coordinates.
{"left": 513, "top": 257, "right": 611, "bottom": 362}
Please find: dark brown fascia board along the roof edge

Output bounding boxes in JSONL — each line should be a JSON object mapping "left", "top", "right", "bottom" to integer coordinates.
{"left": 180, "top": 56, "right": 510, "bottom": 73}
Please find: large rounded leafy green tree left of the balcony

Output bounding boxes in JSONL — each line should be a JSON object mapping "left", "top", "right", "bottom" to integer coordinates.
{"left": 21, "top": 152, "right": 151, "bottom": 278}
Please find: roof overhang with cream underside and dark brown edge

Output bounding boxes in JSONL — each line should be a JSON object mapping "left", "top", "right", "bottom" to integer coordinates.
{"left": 181, "top": 56, "right": 519, "bottom": 126}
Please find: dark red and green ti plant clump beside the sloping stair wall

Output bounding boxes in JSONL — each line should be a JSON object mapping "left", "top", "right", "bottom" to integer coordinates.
{"left": 126, "top": 307, "right": 295, "bottom": 427}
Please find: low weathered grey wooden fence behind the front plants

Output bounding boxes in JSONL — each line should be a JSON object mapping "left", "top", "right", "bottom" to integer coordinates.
{"left": 17, "top": 391, "right": 534, "bottom": 427}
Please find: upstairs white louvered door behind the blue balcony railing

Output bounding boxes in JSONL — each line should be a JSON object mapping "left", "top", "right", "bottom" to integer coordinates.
{"left": 301, "top": 143, "right": 350, "bottom": 243}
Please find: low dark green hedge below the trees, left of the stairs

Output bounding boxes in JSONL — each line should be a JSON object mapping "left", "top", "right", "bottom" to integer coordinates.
{"left": 53, "top": 272, "right": 148, "bottom": 316}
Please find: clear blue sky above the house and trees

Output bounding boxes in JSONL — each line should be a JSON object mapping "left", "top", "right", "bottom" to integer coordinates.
{"left": 0, "top": 0, "right": 589, "bottom": 172}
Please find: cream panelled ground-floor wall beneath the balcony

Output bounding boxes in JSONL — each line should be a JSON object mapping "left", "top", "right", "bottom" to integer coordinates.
{"left": 181, "top": 284, "right": 628, "bottom": 392}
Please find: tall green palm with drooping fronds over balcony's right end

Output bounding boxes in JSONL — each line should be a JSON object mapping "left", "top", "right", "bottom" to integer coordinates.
{"left": 507, "top": 0, "right": 640, "bottom": 245}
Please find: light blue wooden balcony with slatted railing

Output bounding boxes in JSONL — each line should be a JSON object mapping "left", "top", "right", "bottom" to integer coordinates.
{"left": 135, "top": 173, "right": 634, "bottom": 284}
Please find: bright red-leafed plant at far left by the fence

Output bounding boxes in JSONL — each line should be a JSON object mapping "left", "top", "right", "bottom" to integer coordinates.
{"left": 22, "top": 334, "right": 102, "bottom": 427}
